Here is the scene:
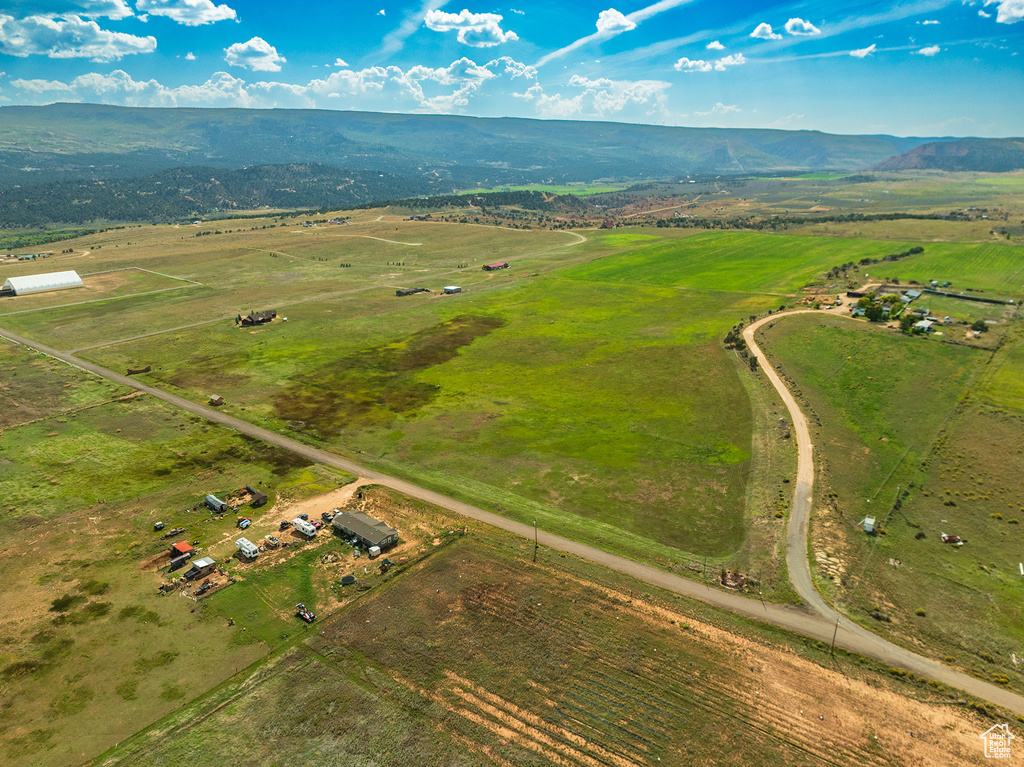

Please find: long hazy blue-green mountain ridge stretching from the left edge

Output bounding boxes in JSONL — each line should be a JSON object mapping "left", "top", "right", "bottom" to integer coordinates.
{"left": 0, "top": 103, "right": 958, "bottom": 188}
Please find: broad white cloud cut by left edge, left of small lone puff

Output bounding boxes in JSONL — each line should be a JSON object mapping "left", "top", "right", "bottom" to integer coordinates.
{"left": 0, "top": 14, "right": 157, "bottom": 61}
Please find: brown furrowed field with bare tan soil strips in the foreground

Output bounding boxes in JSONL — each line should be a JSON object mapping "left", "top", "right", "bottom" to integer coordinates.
{"left": 101, "top": 535, "right": 993, "bottom": 767}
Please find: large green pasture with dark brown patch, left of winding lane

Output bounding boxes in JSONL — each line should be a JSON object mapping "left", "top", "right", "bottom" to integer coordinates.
{"left": 87, "top": 274, "right": 768, "bottom": 558}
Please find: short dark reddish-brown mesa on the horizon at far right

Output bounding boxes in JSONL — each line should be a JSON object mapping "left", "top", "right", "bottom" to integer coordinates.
{"left": 872, "top": 138, "right": 1024, "bottom": 173}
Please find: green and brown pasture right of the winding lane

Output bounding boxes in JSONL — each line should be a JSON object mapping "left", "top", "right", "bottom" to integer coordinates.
{"left": 764, "top": 315, "right": 1024, "bottom": 688}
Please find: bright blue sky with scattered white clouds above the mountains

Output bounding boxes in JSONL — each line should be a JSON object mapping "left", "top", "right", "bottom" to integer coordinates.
{"left": 0, "top": 0, "right": 1024, "bottom": 136}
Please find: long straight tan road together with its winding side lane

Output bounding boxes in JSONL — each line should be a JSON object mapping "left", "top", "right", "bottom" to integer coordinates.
{"left": 0, "top": 314, "right": 1024, "bottom": 716}
